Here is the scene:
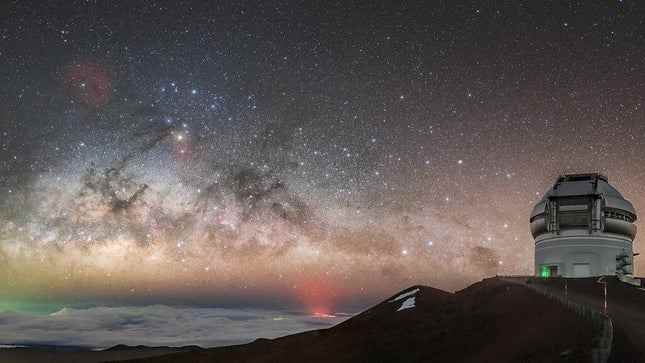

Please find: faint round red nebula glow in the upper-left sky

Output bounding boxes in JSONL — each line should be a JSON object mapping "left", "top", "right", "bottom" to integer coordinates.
{"left": 63, "top": 62, "right": 112, "bottom": 108}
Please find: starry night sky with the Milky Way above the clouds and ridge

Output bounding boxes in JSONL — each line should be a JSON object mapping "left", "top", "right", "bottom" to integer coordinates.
{"left": 0, "top": 0, "right": 645, "bottom": 343}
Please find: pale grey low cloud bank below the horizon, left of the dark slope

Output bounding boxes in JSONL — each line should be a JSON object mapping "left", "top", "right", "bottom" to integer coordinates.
{"left": 0, "top": 305, "right": 347, "bottom": 348}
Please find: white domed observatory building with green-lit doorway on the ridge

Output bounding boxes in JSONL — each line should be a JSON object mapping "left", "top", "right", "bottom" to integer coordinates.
{"left": 530, "top": 174, "right": 636, "bottom": 277}
